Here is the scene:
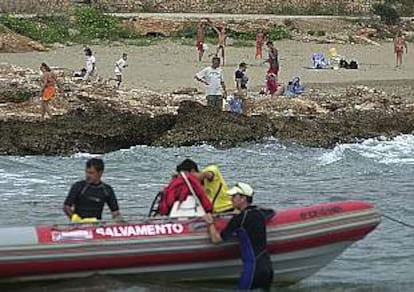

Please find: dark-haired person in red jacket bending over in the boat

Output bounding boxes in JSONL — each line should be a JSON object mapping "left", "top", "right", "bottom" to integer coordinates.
{"left": 158, "top": 159, "right": 213, "bottom": 216}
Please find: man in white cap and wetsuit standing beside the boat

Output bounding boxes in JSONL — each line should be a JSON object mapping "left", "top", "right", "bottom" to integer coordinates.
{"left": 204, "top": 183, "right": 275, "bottom": 290}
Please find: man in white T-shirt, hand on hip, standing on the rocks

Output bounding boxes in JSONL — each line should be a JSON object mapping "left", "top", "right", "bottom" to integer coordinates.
{"left": 194, "top": 57, "right": 226, "bottom": 111}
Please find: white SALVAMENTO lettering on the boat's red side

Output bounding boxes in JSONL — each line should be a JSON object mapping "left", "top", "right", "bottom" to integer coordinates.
{"left": 95, "top": 223, "right": 184, "bottom": 237}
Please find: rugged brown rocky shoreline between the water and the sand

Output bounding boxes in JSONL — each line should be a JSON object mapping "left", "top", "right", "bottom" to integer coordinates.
{"left": 0, "top": 65, "right": 414, "bottom": 155}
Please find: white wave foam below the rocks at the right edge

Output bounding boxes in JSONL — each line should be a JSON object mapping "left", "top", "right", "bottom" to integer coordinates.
{"left": 318, "top": 135, "right": 414, "bottom": 165}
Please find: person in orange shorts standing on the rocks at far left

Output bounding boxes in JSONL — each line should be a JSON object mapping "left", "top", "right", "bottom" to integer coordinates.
{"left": 40, "top": 63, "right": 57, "bottom": 120}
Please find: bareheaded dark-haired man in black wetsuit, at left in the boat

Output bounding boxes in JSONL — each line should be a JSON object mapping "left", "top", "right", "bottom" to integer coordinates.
{"left": 63, "top": 158, "right": 121, "bottom": 221}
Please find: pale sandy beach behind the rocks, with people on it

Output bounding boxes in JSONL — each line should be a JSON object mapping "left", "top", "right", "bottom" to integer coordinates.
{"left": 0, "top": 40, "right": 414, "bottom": 91}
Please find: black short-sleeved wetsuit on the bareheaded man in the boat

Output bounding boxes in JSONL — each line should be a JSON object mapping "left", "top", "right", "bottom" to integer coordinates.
{"left": 64, "top": 180, "right": 119, "bottom": 220}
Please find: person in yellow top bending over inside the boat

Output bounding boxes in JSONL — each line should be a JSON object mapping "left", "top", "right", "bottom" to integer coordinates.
{"left": 199, "top": 165, "right": 234, "bottom": 213}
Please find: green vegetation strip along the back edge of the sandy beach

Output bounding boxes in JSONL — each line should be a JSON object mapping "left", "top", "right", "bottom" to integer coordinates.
{"left": 0, "top": 7, "right": 290, "bottom": 47}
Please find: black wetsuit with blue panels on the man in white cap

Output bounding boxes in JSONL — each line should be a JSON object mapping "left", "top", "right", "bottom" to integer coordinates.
{"left": 221, "top": 206, "right": 275, "bottom": 290}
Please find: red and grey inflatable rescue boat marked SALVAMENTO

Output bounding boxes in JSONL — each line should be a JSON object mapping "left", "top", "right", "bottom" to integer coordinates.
{"left": 0, "top": 201, "right": 382, "bottom": 283}
